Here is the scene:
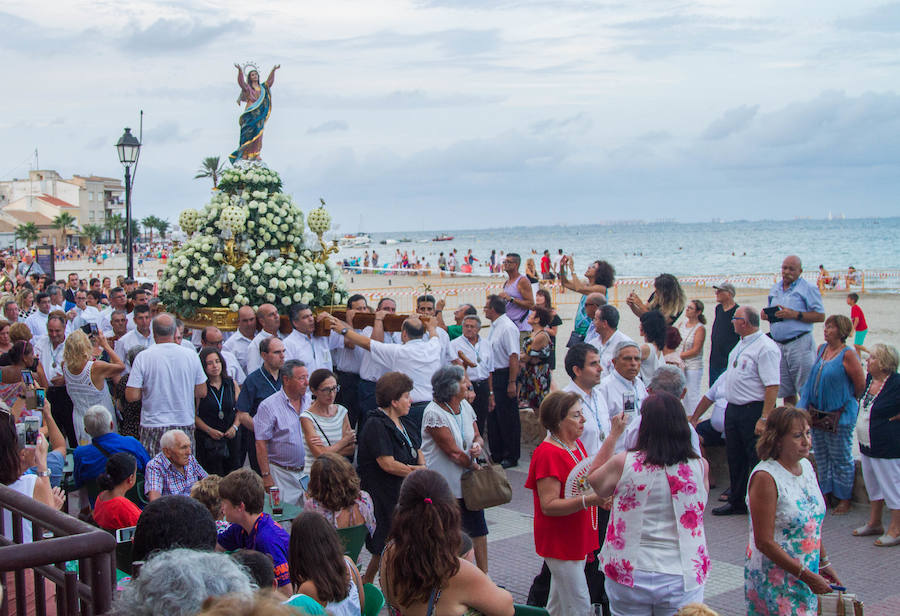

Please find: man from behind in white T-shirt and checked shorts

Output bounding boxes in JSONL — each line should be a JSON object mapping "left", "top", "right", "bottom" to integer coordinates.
{"left": 125, "top": 312, "right": 206, "bottom": 457}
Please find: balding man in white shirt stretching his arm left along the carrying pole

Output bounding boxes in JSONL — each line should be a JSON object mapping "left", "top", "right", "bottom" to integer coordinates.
{"left": 328, "top": 316, "right": 443, "bottom": 434}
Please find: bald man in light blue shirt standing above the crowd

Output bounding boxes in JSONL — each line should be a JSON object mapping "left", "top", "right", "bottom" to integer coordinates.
{"left": 760, "top": 255, "right": 825, "bottom": 404}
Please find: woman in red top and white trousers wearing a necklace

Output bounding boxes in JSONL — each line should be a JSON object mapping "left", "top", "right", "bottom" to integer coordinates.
{"left": 525, "top": 392, "right": 604, "bottom": 616}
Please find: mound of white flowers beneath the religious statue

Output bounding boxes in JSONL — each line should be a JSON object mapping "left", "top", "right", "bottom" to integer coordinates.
{"left": 160, "top": 163, "right": 347, "bottom": 317}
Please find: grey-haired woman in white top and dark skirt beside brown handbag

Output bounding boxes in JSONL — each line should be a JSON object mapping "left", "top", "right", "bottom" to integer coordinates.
{"left": 422, "top": 366, "right": 488, "bottom": 573}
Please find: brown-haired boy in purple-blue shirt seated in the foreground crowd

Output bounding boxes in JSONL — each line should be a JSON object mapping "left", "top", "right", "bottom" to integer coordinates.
{"left": 216, "top": 468, "right": 291, "bottom": 596}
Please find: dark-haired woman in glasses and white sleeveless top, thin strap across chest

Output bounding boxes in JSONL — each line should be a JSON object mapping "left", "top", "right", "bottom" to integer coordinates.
{"left": 300, "top": 368, "right": 356, "bottom": 472}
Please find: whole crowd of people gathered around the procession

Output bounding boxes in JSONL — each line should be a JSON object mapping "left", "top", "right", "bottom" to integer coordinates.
{"left": 0, "top": 247, "right": 900, "bottom": 615}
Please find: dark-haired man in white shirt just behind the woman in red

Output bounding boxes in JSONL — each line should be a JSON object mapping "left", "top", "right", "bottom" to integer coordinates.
{"left": 563, "top": 342, "right": 612, "bottom": 457}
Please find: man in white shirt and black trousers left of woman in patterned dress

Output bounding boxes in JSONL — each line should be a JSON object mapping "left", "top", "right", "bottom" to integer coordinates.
{"left": 484, "top": 295, "right": 522, "bottom": 468}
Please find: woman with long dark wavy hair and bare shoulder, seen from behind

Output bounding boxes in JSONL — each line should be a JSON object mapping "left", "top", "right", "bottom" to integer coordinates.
{"left": 381, "top": 470, "right": 512, "bottom": 616}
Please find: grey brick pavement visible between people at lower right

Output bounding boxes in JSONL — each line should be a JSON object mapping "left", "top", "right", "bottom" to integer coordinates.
{"left": 478, "top": 452, "right": 900, "bottom": 616}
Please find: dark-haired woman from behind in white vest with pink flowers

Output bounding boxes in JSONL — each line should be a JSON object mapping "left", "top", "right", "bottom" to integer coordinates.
{"left": 590, "top": 393, "right": 710, "bottom": 614}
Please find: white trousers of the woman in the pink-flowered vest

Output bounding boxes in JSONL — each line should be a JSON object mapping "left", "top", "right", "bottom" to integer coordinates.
{"left": 604, "top": 569, "right": 703, "bottom": 616}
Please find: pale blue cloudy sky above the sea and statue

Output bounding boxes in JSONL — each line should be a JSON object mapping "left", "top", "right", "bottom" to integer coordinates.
{"left": 0, "top": 0, "right": 900, "bottom": 232}
